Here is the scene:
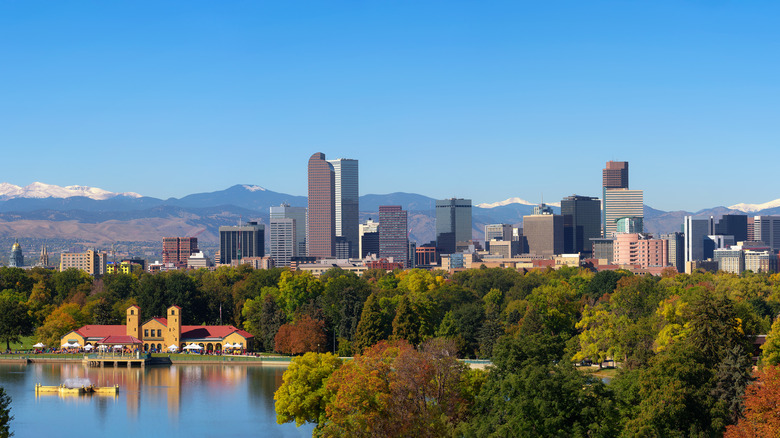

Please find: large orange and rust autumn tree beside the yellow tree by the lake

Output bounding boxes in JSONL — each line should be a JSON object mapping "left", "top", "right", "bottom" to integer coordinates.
{"left": 316, "top": 340, "right": 471, "bottom": 438}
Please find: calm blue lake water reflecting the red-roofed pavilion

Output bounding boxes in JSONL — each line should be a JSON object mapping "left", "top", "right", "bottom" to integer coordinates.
{"left": 0, "top": 363, "right": 314, "bottom": 438}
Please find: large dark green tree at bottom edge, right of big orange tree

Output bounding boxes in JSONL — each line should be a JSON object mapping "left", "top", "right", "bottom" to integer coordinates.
{"left": 460, "top": 335, "right": 617, "bottom": 437}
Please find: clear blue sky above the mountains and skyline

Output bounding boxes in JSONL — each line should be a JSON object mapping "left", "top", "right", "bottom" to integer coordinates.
{"left": 0, "top": 0, "right": 780, "bottom": 211}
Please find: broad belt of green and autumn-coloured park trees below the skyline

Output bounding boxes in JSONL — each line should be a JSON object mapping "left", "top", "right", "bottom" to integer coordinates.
{"left": 0, "top": 266, "right": 780, "bottom": 436}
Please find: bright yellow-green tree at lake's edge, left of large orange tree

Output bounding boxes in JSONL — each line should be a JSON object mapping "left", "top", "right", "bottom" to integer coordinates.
{"left": 274, "top": 353, "right": 341, "bottom": 426}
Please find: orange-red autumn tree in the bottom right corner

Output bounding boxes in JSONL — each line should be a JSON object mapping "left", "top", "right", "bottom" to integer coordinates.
{"left": 724, "top": 365, "right": 780, "bottom": 438}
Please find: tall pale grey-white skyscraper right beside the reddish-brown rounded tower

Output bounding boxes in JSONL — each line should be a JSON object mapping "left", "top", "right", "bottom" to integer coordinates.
{"left": 328, "top": 158, "right": 360, "bottom": 257}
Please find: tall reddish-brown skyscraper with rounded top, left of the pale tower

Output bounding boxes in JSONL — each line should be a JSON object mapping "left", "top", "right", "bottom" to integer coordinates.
{"left": 306, "top": 152, "right": 336, "bottom": 257}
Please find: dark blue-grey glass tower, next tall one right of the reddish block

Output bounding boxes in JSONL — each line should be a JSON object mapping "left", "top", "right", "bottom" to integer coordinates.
{"left": 436, "top": 198, "right": 471, "bottom": 254}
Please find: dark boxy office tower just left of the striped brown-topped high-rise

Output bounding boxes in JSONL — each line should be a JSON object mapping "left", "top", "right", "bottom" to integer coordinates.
{"left": 561, "top": 195, "right": 601, "bottom": 258}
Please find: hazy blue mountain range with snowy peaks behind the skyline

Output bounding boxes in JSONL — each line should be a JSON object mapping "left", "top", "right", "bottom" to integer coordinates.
{"left": 0, "top": 182, "right": 780, "bottom": 245}
